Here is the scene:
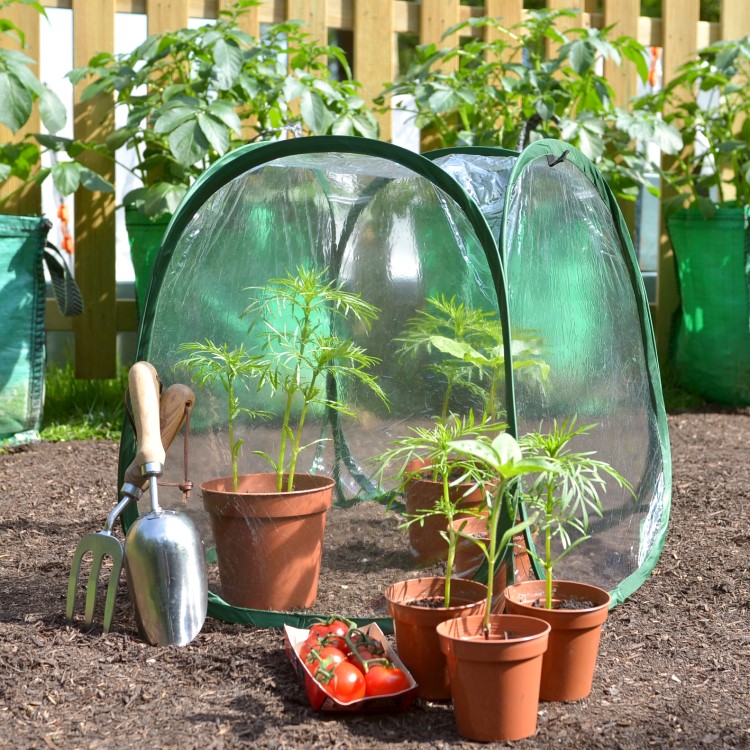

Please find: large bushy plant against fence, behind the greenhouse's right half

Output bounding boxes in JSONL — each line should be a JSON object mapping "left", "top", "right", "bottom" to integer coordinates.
{"left": 377, "top": 10, "right": 679, "bottom": 199}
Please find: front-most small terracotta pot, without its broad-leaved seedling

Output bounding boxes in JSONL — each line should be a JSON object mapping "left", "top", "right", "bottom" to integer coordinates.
{"left": 437, "top": 615, "right": 550, "bottom": 742}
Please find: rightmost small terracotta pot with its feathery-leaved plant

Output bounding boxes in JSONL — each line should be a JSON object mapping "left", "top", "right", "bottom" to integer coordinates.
{"left": 505, "top": 418, "right": 633, "bottom": 701}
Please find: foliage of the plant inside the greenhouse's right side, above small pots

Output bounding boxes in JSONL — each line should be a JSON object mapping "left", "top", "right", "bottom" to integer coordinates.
{"left": 396, "top": 295, "right": 549, "bottom": 421}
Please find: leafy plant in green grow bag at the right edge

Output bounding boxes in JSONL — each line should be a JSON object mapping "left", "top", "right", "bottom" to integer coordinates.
{"left": 637, "top": 37, "right": 750, "bottom": 404}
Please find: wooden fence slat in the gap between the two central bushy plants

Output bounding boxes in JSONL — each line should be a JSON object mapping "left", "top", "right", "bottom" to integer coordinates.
{"left": 353, "top": 0, "right": 398, "bottom": 141}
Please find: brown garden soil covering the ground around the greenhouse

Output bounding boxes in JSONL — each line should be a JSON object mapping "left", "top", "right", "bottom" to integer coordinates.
{"left": 0, "top": 410, "right": 750, "bottom": 750}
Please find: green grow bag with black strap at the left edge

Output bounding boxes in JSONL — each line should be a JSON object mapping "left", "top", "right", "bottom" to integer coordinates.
{"left": 0, "top": 215, "right": 51, "bottom": 445}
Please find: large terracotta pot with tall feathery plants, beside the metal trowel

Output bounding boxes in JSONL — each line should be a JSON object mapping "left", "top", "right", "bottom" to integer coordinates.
{"left": 177, "top": 268, "right": 388, "bottom": 610}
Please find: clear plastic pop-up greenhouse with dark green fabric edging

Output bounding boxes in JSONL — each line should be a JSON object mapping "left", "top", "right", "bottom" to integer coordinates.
{"left": 120, "top": 137, "right": 670, "bottom": 624}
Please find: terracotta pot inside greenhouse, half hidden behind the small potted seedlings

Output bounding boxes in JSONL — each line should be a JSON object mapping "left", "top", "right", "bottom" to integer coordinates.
{"left": 404, "top": 469, "right": 483, "bottom": 565}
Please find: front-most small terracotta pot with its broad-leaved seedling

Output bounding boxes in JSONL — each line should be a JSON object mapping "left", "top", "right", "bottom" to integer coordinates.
{"left": 436, "top": 432, "right": 555, "bottom": 742}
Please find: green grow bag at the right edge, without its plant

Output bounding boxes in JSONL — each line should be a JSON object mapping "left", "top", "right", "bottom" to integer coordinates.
{"left": 668, "top": 206, "right": 750, "bottom": 405}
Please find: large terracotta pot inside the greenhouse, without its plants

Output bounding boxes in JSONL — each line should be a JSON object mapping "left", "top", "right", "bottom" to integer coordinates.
{"left": 200, "top": 474, "right": 335, "bottom": 610}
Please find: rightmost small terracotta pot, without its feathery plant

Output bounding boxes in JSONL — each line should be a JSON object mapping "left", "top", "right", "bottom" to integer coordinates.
{"left": 505, "top": 581, "right": 611, "bottom": 701}
